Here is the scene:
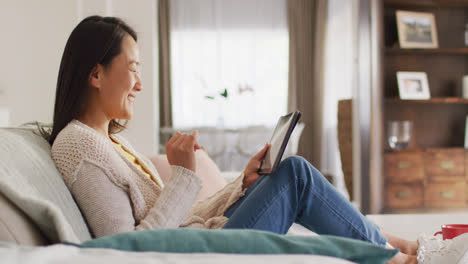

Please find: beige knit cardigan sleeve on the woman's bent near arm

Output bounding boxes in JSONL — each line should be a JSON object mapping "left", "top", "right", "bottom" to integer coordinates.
{"left": 70, "top": 161, "right": 201, "bottom": 237}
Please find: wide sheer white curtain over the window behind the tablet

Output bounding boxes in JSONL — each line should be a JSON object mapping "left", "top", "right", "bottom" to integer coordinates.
{"left": 170, "top": 0, "right": 289, "bottom": 128}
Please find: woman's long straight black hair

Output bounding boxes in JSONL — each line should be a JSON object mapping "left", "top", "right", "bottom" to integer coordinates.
{"left": 49, "top": 16, "right": 137, "bottom": 145}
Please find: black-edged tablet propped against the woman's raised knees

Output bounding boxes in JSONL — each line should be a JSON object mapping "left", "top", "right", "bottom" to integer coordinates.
{"left": 258, "top": 111, "right": 301, "bottom": 174}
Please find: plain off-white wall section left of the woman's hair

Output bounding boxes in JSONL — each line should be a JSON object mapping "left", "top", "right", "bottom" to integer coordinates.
{"left": 0, "top": 0, "right": 77, "bottom": 125}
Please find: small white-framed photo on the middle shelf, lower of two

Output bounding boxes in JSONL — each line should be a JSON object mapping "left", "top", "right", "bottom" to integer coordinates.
{"left": 397, "top": 72, "right": 431, "bottom": 100}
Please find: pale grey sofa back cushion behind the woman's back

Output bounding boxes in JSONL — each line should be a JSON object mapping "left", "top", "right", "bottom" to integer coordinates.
{"left": 0, "top": 128, "right": 91, "bottom": 243}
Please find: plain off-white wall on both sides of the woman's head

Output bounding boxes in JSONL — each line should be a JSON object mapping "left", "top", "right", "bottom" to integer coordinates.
{"left": 0, "top": 0, "right": 159, "bottom": 154}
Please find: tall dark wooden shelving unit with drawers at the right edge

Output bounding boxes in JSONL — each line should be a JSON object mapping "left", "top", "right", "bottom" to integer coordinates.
{"left": 380, "top": 0, "right": 468, "bottom": 212}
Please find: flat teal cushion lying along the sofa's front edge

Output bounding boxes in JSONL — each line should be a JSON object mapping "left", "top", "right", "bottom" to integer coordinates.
{"left": 77, "top": 228, "right": 398, "bottom": 264}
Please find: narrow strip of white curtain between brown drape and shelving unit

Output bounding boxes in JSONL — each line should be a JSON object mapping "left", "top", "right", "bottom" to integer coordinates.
{"left": 321, "top": 0, "right": 359, "bottom": 198}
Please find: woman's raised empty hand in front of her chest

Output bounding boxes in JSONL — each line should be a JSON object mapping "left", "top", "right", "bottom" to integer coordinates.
{"left": 166, "top": 130, "right": 200, "bottom": 172}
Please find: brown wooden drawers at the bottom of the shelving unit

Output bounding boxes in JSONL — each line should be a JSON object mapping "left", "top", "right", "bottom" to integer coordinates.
{"left": 384, "top": 148, "right": 468, "bottom": 209}
